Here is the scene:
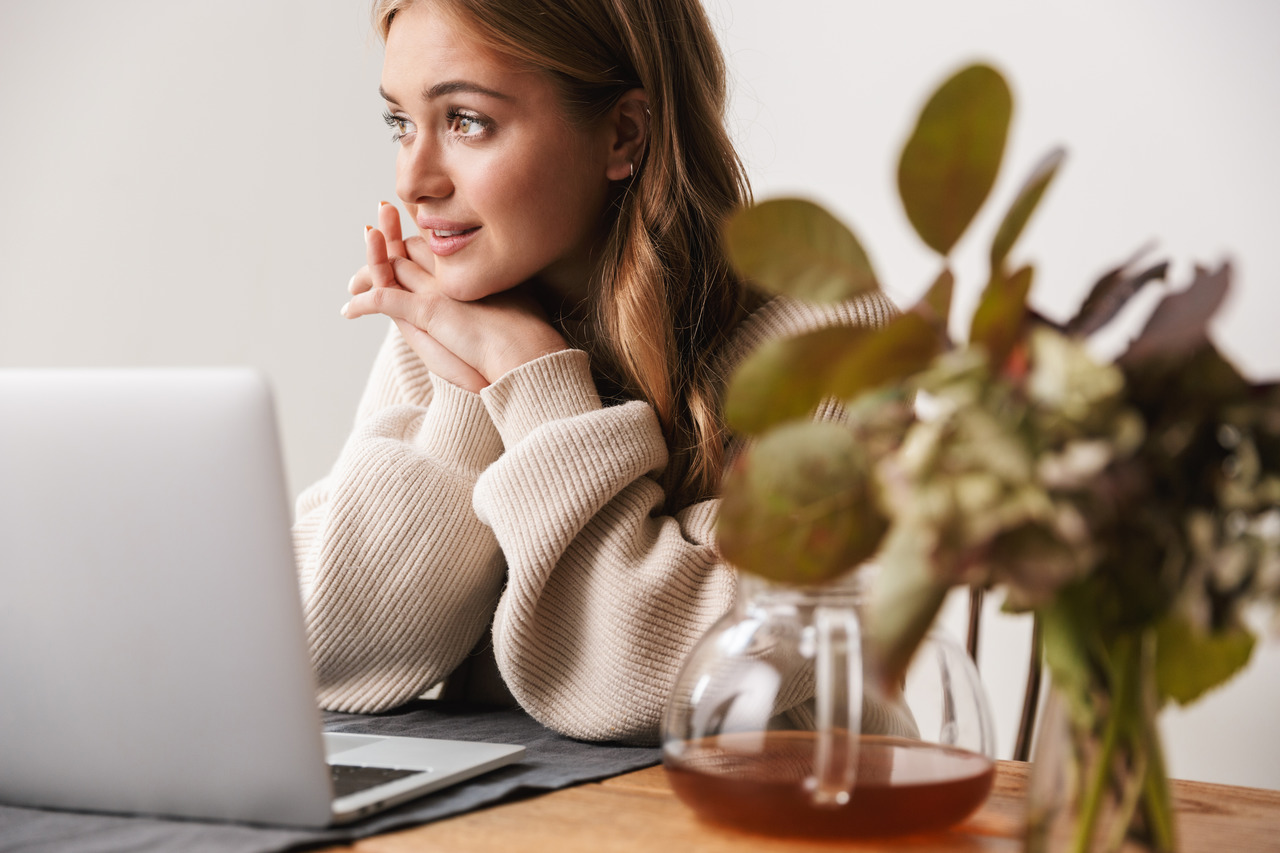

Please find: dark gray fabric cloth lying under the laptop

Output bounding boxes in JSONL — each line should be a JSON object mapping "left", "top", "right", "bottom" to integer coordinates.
{"left": 0, "top": 701, "right": 659, "bottom": 853}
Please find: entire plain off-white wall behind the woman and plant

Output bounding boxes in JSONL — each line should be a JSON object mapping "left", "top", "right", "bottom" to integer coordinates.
{"left": 0, "top": 0, "right": 1280, "bottom": 788}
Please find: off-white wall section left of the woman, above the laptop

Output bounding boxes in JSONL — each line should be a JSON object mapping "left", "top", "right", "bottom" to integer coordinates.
{"left": 0, "top": 0, "right": 394, "bottom": 499}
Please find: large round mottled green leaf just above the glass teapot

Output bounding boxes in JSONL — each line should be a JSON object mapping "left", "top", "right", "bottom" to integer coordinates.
{"left": 717, "top": 421, "right": 886, "bottom": 583}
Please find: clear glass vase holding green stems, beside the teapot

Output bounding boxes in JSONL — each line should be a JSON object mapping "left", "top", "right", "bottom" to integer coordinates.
{"left": 1025, "top": 630, "right": 1176, "bottom": 853}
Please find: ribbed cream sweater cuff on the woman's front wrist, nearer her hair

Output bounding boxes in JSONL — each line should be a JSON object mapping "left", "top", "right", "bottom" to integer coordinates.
{"left": 480, "top": 350, "right": 602, "bottom": 447}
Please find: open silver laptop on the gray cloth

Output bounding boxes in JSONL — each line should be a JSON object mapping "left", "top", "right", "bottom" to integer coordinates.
{"left": 0, "top": 369, "right": 524, "bottom": 826}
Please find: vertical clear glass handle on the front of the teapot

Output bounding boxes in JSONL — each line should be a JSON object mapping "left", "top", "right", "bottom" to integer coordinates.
{"left": 806, "top": 605, "right": 863, "bottom": 808}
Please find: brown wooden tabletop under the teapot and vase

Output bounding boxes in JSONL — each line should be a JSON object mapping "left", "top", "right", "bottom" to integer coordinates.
{"left": 333, "top": 761, "right": 1280, "bottom": 853}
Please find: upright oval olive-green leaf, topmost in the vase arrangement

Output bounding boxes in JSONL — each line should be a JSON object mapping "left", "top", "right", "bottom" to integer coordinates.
{"left": 897, "top": 65, "right": 1014, "bottom": 255}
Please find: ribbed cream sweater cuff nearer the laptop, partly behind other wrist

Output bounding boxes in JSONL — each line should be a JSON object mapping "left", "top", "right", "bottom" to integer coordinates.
{"left": 416, "top": 373, "right": 502, "bottom": 478}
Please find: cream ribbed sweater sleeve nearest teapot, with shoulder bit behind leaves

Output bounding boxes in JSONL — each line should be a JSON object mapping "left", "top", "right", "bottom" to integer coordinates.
{"left": 475, "top": 290, "right": 893, "bottom": 742}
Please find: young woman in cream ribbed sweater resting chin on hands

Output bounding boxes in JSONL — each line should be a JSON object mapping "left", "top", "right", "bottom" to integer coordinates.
{"left": 296, "top": 0, "right": 892, "bottom": 740}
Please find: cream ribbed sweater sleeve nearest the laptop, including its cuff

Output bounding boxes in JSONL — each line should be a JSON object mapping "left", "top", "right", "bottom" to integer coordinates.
{"left": 293, "top": 327, "right": 503, "bottom": 712}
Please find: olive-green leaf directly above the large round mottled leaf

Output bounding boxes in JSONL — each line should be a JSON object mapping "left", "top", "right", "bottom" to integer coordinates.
{"left": 724, "top": 327, "right": 873, "bottom": 435}
